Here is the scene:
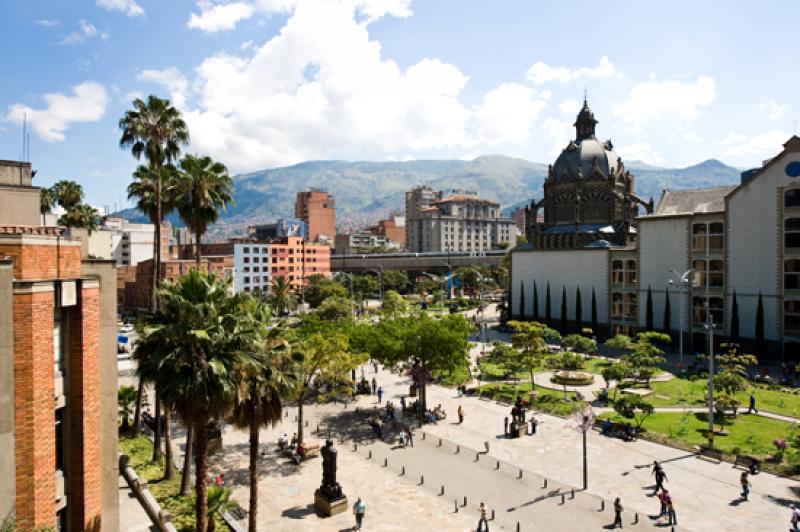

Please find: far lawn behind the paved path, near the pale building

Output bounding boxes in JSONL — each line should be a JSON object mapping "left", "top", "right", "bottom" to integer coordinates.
{"left": 647, "top": 378, "right": 800, "bottom": 417}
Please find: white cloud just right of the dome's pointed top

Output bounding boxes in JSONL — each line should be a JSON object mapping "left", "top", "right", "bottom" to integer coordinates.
{"left": 611, "top": 76, "right": 717, "bottom": 129}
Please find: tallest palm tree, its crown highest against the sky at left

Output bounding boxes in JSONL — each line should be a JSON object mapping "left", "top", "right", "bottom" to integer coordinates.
{"left": 119, "top": 95, "right": 189, "bottom": 310}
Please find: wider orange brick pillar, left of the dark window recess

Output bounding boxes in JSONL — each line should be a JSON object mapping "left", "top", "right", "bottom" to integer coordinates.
{"left": 13, "top": 288, "right": 56, "bottom": 529}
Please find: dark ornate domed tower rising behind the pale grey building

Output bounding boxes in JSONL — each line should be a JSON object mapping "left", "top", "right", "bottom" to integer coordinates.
{"left": 526, "top": 100, "right": 653, "bottom": 249}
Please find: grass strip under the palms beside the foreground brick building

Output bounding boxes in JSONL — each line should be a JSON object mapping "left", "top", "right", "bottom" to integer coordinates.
{"left": 119, "top": 434, "right": 228, "bottom": 532}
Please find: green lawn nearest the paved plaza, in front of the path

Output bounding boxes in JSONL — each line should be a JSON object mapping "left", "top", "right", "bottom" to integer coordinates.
{"left": 600, "top": 412, "right": 792, "bottom": 458}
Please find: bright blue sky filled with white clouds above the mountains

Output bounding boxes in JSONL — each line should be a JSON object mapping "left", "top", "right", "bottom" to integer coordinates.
{"left": 0, "top": 0, "right": 800, "bottom": 212}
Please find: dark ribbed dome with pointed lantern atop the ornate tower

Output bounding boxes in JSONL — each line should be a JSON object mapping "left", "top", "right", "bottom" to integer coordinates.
{"left": 551, "top": 100, "right": 624, "bottom": 179}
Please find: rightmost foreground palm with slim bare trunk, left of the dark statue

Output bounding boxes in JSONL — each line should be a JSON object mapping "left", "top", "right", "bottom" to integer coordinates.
{"left": 231, "top": 298, "right": 293, "bottom": 532}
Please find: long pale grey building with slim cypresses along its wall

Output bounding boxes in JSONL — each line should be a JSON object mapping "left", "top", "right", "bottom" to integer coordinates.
{"left": 511, "top": 136, "right": 800, "bottom": 362}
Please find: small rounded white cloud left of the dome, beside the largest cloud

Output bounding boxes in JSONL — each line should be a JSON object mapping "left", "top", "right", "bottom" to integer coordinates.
{"left": 473, "top": 83, "right": 546, "bottom": 144}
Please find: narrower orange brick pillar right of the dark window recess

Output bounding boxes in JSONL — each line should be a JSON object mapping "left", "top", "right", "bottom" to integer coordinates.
{"left": 67, "top": 281, "right": 102, "bottom": 530}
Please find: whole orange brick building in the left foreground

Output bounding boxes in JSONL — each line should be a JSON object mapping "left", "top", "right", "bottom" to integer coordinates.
{"left": 0, "top": 161, "right": 119, "bottom": 531}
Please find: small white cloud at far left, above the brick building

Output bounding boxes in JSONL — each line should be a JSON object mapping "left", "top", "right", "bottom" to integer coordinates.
{"left": 6, "top": 81, "right": 108, "bottom": 142}
